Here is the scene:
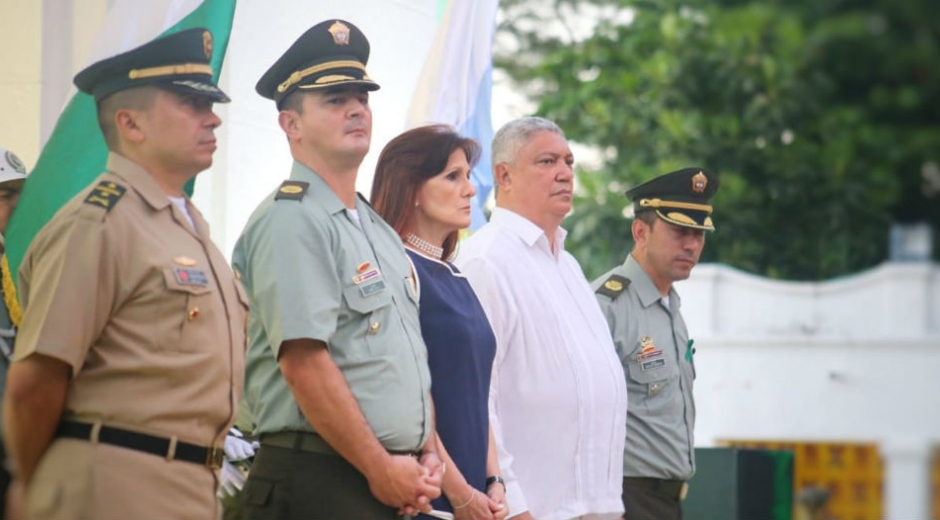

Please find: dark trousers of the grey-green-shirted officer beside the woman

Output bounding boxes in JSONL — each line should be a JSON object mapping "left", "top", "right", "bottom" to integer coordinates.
{"left": 242, "top": 443, "right": 399, "bottom": 520}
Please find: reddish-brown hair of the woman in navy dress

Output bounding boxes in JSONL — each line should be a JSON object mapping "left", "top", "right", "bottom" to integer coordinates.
{"left": 370, "top": 125, "right": 482, "bottom": 258}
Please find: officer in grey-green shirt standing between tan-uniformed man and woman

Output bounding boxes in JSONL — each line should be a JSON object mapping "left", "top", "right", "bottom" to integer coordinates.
{"left": 233, "top": 20, "right": 443, "bottom": 519}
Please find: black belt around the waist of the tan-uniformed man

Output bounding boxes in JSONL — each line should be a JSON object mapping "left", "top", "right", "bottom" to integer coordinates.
{"left": 55, "top": 421, "right": 224, "bottom": 469}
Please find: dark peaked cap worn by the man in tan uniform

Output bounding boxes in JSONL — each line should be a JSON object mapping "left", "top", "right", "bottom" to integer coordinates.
{"left": 75, "top": 28, "right": 229, "bottom": 103}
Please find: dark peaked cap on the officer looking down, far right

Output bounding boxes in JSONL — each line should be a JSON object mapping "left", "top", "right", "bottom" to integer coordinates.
{"left": 626, "top": 168, "right": 718, "bottom": 231}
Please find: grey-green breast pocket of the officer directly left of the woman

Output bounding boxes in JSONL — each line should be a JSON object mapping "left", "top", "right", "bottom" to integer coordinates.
{"left": 343, "top": 278, "right": 398, "bottom": 358}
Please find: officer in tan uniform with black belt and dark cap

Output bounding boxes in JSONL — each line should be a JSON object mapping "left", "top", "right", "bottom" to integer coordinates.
{"left": 5, "top": 29, "right": 247, "bottom": 519}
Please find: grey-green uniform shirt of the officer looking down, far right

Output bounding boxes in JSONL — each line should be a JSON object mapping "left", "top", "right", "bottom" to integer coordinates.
{"left": 591, "top": 255, "right": 695, "bottom": 480}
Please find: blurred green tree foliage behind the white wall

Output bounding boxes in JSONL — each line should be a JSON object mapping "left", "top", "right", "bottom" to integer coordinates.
{"left": 495, "top": 0, "right": 940, "bottom": 280}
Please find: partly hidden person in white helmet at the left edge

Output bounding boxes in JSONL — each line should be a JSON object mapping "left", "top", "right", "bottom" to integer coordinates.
{"left": 0, "top": 148, "right": 26, "bottom": 514}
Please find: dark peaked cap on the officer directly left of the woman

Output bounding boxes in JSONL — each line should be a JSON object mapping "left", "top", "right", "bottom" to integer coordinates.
{"left": 255, "top": 20, "right": 379, "bottom": 107}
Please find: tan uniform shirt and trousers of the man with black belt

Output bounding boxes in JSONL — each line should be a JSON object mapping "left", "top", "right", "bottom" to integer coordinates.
{"left": 14, "top": 153, "right": 247, "bottom": 518}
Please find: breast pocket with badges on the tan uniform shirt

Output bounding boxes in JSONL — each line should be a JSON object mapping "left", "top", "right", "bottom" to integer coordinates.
{"left": 165, "top": 268, "right": 222, "bottom": 352}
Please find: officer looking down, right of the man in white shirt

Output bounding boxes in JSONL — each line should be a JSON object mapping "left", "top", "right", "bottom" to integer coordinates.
{"left": 592, "top": 168, "right": 718, "bottom": 520}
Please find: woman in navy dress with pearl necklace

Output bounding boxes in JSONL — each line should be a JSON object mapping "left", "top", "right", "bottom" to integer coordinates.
{"left": 371, "top": 125, "right": 508, "bottom": 520}
